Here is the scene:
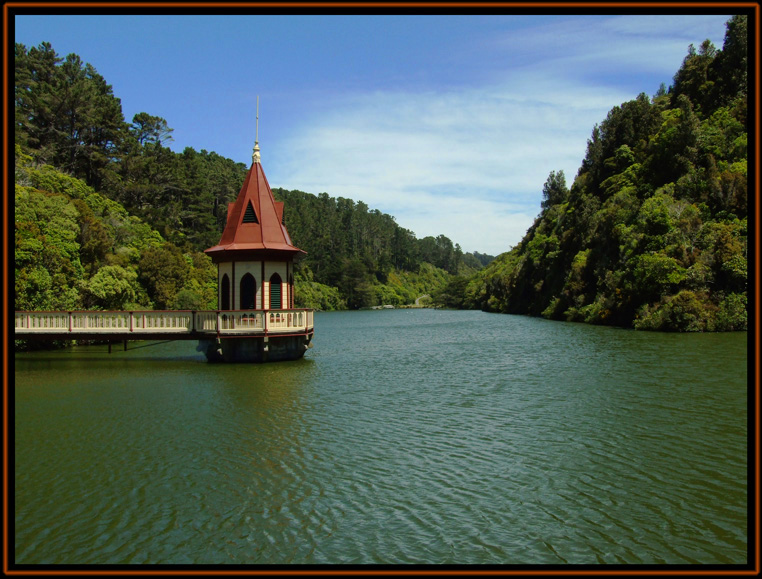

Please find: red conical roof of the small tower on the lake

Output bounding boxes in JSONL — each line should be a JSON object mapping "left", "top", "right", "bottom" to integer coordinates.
{"left": 204, "top": 159, "right": 304, "bottom": 258}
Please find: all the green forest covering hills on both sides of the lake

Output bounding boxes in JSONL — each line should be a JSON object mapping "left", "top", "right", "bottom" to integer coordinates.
{"left": 15, "top": 16, "right": 753, "bottom": 331}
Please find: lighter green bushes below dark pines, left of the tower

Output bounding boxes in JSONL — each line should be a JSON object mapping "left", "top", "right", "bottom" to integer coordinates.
{"left": 15, "top": 155, "right": 217, "bottom": 318}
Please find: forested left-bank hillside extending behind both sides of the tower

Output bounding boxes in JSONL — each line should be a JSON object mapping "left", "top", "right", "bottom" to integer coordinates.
{"left": 15, "top": 43, "right": 491, "bottom": 322}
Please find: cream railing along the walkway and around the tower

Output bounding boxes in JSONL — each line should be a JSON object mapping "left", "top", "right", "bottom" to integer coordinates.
{"left": 15, "top": 309, "right": 314, "bottom": 339}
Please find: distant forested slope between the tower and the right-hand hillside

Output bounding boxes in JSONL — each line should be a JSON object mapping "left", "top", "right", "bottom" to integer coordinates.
{"left": 273, "top": 189, "right": 478, "bottom": 309}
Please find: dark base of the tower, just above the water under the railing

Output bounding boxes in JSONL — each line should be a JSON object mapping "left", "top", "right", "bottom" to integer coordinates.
{"left": 196, "top": 334, "right": 312, "bottom": 363}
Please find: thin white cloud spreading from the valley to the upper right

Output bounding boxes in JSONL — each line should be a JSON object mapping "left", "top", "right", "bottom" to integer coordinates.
{"left": 263, "top": 16, "right": 732, "bottom": 255}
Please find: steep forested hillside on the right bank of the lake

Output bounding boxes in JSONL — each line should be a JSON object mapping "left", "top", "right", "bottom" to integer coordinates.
{"left": 440, "top": 16, "right": 749, "bottom": 331}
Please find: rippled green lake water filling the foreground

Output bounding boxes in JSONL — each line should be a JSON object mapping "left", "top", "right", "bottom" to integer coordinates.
{"left": 13, "top": 310, "right": 748, "bottom": 565}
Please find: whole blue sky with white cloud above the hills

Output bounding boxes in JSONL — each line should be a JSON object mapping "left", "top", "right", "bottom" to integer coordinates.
{"left": 14, "top": 9, "right": 730, "bottom": 255}
